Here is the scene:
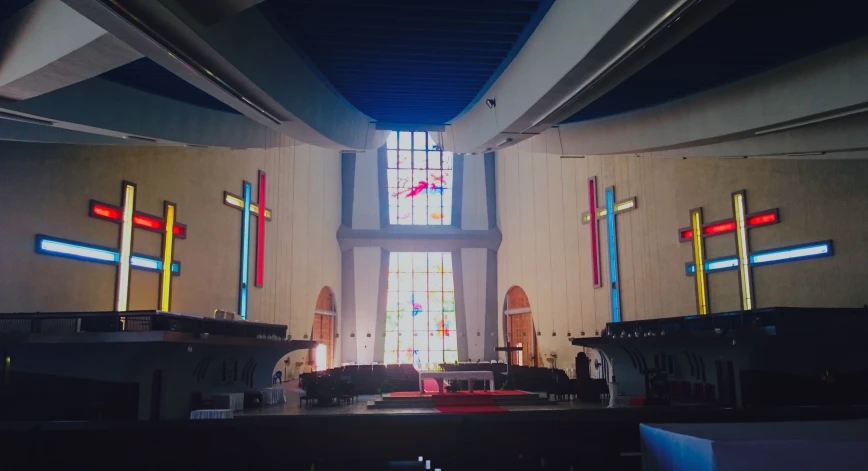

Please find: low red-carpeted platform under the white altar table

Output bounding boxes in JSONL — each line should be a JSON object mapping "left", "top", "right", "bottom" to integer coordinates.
{"left": 368, "top": 390, "right": 556, "bottom": 413}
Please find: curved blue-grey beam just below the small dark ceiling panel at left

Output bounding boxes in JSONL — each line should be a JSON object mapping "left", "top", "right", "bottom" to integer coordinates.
{"left": 0, "top": 78, "right": 273, "bottom": 148}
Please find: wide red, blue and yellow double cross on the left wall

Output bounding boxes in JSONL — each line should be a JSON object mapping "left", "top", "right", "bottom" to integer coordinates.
{"left": 36, "top": 181, "right": 187, "bottom": 312}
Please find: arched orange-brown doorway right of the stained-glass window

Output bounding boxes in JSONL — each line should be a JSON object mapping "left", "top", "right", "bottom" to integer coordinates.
{"left": 503, "top": 286, "right": 540, "bottom": 366}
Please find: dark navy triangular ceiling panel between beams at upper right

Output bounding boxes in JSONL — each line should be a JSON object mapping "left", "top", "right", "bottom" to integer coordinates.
{"left": 564, "top": 0, "right": 868, "bottom": 123}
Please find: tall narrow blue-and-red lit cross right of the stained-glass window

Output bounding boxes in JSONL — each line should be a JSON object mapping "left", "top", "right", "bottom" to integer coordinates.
{"left": 582, "top": 177, "right": 636, "bottom": 322}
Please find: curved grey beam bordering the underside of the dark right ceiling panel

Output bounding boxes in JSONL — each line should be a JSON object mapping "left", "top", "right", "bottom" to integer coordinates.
{"left": 559, "top": 39, "right": 868, "bottom": 155}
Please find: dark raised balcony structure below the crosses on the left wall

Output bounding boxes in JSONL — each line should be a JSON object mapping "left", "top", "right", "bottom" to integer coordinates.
{"left": 0, "top": 311, "right": 316, "bottom": 420}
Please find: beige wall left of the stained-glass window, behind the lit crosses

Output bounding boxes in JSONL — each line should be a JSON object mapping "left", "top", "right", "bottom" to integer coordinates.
{"left": 0, "top": 135, "right": 341, "bottom": 366}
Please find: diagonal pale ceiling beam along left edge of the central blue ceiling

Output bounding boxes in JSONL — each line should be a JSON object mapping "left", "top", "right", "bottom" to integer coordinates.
{"left": 63, "top": 0, "right": 385, "bottom": 149}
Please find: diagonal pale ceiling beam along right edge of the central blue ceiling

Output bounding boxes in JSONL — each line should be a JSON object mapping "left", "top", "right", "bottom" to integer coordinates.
{"left": 446, "top": 0, "right": 733, "bottom": 152}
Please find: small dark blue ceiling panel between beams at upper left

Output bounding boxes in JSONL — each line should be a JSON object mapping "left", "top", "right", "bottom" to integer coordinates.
{"left": 99, "top": 58, "right": 239, "bottom": 114}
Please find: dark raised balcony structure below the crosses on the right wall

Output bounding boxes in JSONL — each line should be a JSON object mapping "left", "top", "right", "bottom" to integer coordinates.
{"left": 572, "top": 307, "right": 868, "bottom": 407}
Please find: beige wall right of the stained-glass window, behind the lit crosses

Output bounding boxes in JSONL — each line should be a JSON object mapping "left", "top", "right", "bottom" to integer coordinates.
{"left": 496, "top": 130, "right": 868, "bottom": 367}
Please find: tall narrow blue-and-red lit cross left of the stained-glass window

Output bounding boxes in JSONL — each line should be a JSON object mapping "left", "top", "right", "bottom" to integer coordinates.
{"left": 223, "top": 170, "right": 271, "bottom": 319}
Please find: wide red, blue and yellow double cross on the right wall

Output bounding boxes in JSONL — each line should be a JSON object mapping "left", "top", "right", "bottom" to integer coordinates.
{"left": 678, "top": 190, "right": 832, "bottom": 315}
